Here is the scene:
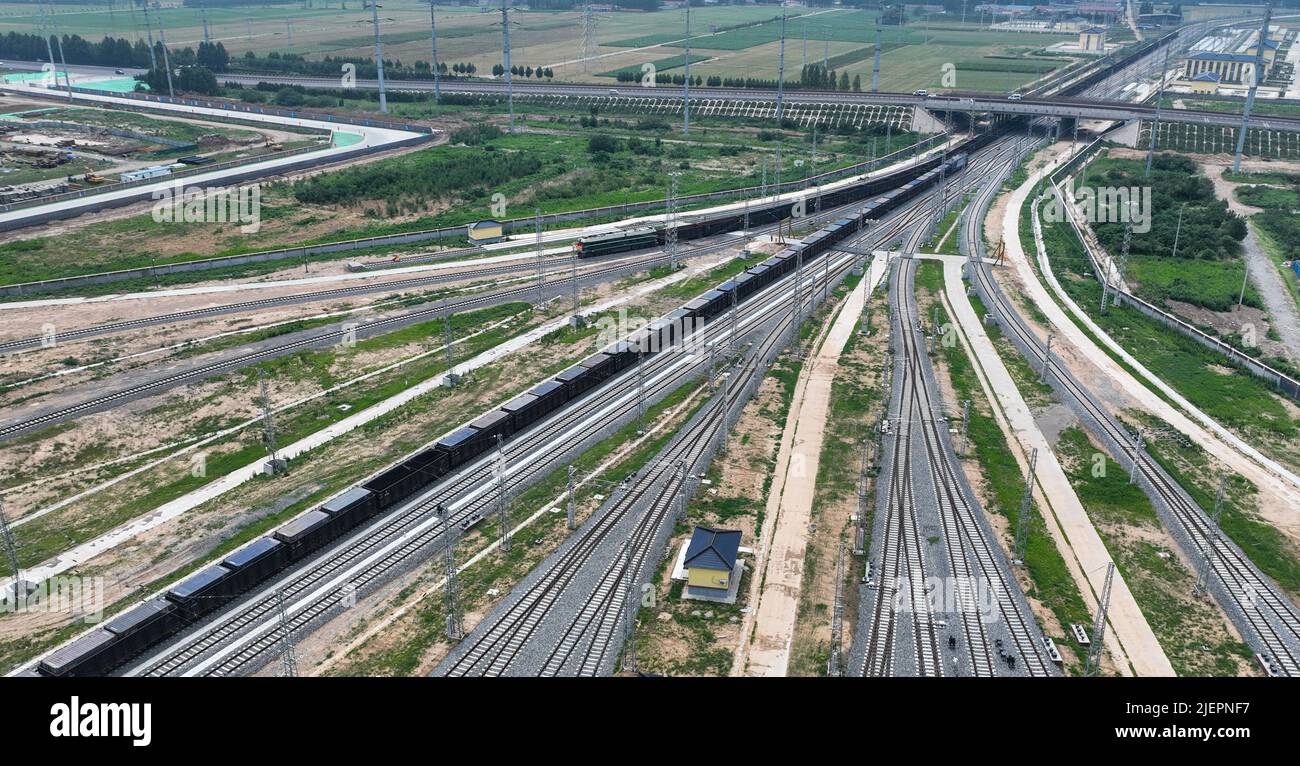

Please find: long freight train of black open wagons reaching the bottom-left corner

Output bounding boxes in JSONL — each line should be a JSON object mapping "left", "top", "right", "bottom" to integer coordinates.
{"left": 22, "top": 137, "right": 991, "bottom": 676}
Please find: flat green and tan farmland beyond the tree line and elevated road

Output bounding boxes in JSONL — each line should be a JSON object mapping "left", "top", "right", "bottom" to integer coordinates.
{"left": 0, "top": 0, "right": 1070, "bottom": 92}
